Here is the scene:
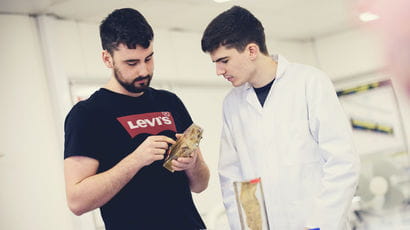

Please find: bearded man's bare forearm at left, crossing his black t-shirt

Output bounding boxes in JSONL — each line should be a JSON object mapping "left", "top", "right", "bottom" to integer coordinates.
{"left": 67, "top": 154, "right": 142, "bottom": 215}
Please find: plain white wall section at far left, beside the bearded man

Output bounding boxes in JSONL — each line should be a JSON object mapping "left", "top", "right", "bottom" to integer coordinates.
{"left": 0, "top": 15, "right": 74, "bottom": 230}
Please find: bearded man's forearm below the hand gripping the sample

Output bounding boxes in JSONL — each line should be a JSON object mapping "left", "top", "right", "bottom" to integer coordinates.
{"left": 185, "top": 152, "right": 209, "bottom": 193}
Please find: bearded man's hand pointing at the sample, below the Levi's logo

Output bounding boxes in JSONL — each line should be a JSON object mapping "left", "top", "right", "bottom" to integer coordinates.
{"left": 132, "top": 136, "right": 175, "bottom": 166}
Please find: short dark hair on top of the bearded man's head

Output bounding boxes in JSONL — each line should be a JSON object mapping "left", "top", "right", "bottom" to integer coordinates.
{"left": 100, "top": 8, "right": 154, "bottom": 55}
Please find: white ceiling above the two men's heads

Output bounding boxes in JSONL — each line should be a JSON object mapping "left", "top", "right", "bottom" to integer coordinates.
{"left": 0, "top": 0, "right": 358, "bottom": 40}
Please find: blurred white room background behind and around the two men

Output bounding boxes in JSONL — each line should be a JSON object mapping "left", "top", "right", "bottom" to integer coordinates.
{"left": 0, "top": 0, "right": 410, "bottom": 230}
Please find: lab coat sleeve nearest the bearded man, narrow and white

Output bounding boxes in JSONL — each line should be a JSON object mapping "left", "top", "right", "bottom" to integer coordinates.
{"left": 218, "top": 101, "right": 241, "bottom": 229}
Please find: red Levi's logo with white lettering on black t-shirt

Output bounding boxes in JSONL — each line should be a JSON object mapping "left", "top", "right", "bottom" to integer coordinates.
{"left": 117, "top": 112, "right": 177, "bottom": 138}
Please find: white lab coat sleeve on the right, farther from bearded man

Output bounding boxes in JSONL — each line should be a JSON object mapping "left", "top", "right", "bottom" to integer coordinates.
{"left": 305, "top": 73, "right": 360, "bottom": 230}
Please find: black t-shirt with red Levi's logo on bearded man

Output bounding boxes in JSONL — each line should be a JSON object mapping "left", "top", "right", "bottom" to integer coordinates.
{"left": 64, "top": 88, "right": 205, "bottom": 230}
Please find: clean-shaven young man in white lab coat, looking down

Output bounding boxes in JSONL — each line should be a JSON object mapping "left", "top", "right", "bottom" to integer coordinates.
{"left": 201, "top": 6, "right": 359, "bottom": 230}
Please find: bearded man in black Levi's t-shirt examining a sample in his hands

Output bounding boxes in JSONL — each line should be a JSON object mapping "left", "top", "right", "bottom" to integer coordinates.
{"left": 64, "top": 8, "right": 209, "bottom": 230}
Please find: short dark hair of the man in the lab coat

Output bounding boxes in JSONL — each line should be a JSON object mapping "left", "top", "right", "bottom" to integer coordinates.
{"left": 201, "top": 6, "right": 268, "bottom": 55}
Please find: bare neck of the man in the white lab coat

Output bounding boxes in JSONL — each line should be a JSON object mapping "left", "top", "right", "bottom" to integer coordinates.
{"left": 250, "top": 55, "right": 278, "bottom": 88}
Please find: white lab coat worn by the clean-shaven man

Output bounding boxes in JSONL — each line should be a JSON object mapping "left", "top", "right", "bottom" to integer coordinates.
{"left": 218, "top": 56, "right": 359, "bottom": 230}
